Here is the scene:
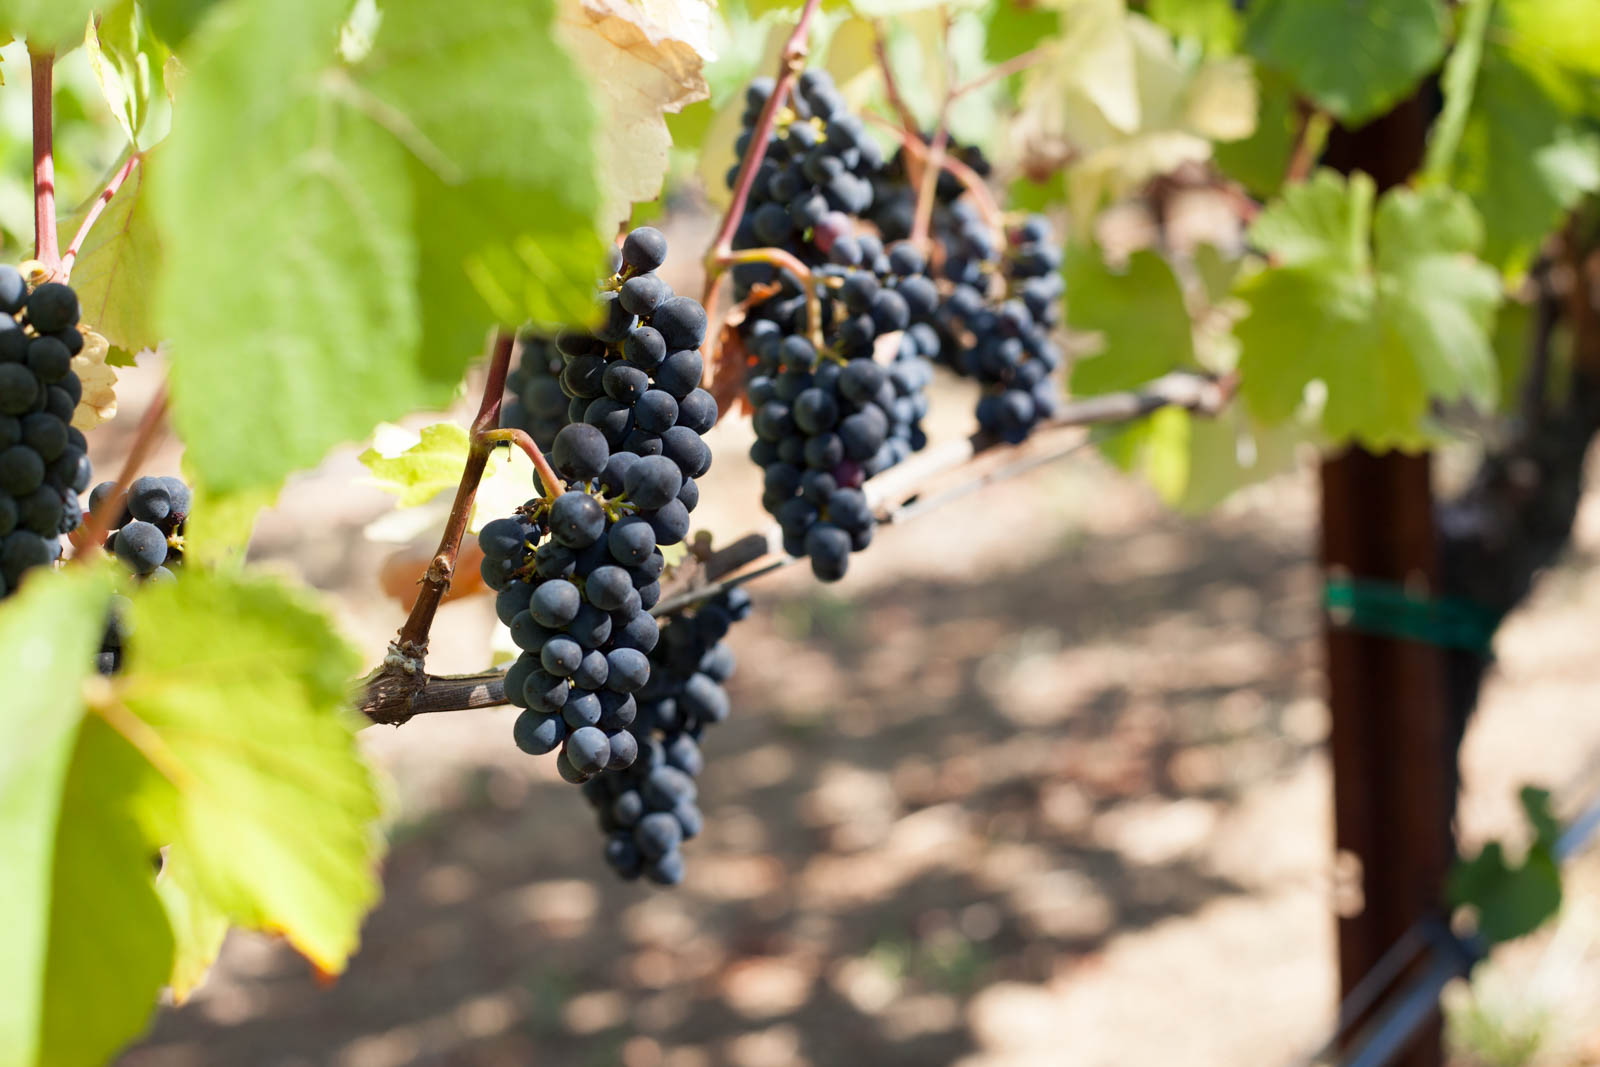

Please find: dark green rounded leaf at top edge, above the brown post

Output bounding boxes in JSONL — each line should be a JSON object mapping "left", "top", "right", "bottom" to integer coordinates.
{"left": 1246, "top": 0, "right": 1450, "bottom": 126}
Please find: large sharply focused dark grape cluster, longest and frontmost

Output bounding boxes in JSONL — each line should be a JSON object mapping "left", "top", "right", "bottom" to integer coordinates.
{"left": 478, "top": 227, "right": 717, "bottom": 782}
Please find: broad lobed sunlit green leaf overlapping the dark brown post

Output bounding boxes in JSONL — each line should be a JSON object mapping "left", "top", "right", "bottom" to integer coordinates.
{"left": 1235, "top": 171, "right": 1501, "bottom": 450}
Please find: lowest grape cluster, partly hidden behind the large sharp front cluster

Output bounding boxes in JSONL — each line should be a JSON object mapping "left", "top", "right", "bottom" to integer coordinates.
{"left": 584, "top": 589, "right": 750, "bottom": 885}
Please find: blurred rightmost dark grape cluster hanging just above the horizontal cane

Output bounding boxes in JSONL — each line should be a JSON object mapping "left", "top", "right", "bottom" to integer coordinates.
{"left": 939, "top": 211, "right": 1062, "bottom": 443}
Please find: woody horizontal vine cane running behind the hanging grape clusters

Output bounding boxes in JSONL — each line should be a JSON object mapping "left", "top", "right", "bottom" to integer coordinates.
{"left": 360, "top": 374, "right": 1237, "bottom": 726}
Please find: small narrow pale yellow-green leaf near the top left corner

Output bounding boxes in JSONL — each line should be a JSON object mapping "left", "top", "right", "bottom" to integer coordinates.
{"left": 83, "top": 0, "right": 171, "bottom": 149}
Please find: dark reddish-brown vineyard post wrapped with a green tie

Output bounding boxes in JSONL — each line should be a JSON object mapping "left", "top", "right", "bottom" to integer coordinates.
{"left": 1322, "top": 98, "right": 1456, "bottom": 1067}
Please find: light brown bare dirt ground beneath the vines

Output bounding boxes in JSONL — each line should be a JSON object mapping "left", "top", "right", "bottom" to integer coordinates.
{"left": 109, "top": 347, "right": 1600, "bottom": 1067}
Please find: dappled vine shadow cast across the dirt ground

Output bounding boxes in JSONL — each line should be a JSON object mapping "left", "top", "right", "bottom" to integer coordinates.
{"left": 122, "top": 508, "right": 1322, "bottom": 1067}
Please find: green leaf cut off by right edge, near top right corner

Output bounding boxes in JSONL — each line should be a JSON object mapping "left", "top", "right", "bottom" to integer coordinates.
{"left": 1450, "top": 27, "right": 1600, "bottom": 275}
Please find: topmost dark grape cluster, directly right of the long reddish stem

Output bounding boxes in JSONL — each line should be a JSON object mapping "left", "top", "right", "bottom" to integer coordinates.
{"left": 728, "top": 70, "right": 883, "bottom": 298}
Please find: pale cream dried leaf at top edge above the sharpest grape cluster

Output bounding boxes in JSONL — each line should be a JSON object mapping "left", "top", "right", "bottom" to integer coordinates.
{"left": 555, "top": 0, "right": 712, "bottom": 222}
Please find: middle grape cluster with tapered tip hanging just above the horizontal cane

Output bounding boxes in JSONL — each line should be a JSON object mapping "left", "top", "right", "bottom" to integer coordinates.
{"left": 742, "top": 241, "right": 941, "bottom": 581}
